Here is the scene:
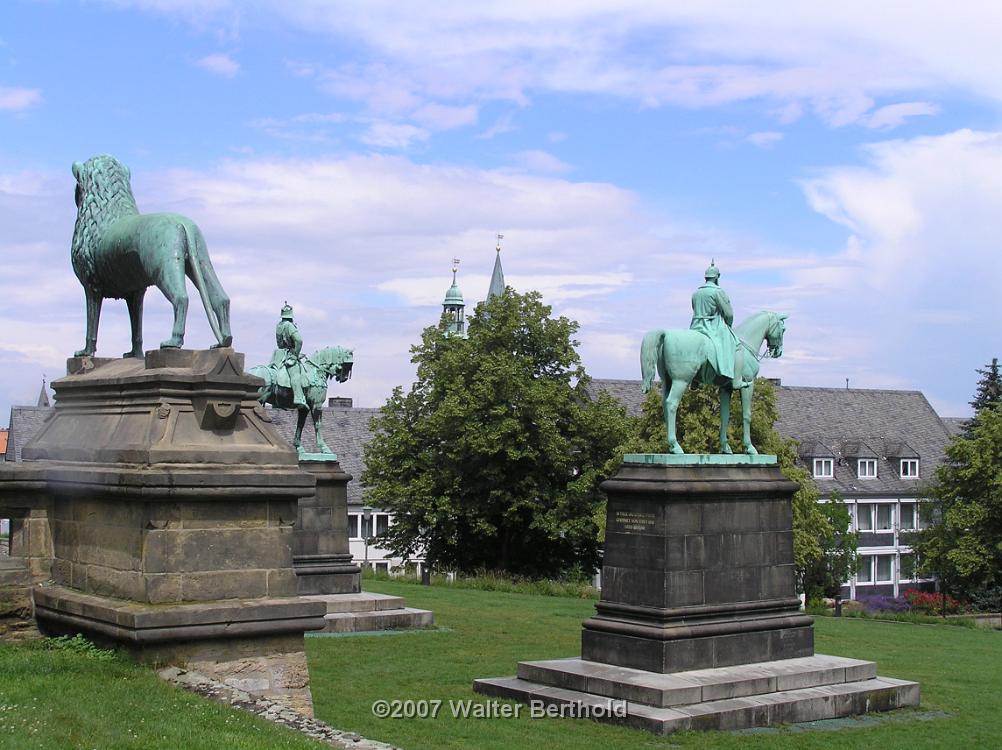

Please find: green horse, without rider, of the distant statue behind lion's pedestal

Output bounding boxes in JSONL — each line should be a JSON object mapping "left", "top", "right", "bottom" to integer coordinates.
{"left": 249, "top": 346, "right": 354, "bottom": 454}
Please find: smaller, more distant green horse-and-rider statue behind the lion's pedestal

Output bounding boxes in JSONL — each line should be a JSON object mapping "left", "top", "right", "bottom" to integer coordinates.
{"left": 249, "top": 302, "right": 354, "bottom": 456}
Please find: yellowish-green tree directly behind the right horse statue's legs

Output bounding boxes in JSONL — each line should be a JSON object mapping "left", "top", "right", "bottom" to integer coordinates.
{"left": 603, "top": 379, "right": 834, "bottom": 582}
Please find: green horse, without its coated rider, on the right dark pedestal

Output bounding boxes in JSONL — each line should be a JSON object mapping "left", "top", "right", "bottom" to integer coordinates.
{"left": 640, "top": 310, "right": 787, "bottom": 454}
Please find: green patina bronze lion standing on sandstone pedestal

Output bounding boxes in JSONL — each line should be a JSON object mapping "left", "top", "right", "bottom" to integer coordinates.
{"left": 70, "top": 155, "right": 233, "bottom": 356}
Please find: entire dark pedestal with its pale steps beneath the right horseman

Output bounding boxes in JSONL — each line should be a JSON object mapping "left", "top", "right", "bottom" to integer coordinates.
{"left": 473, "top": 455, "right": 919, "bottom": 734}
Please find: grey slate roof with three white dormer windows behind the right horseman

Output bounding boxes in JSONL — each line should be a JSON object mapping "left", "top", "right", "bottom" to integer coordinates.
{"left": 588, "top": 380, "right": 953, "bottom": 498}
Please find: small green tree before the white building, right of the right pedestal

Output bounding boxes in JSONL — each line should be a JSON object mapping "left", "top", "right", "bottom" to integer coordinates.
{"left": 803, "top": 493, "right": 860, "bottom": 615}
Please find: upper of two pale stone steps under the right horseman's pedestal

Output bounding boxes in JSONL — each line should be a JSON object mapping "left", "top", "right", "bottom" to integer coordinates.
{"left": 517, "top": 654, "right": 877, "bottom": 708}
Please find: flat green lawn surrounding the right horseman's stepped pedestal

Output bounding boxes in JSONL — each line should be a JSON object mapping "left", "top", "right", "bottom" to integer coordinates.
{"left": 307, "top": 581, "right": 1002, "bottom": 750}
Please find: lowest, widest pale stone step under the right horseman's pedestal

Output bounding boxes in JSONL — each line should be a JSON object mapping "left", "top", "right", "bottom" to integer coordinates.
{"left": 473, "top": 677, "right": 920, "bottom": 735}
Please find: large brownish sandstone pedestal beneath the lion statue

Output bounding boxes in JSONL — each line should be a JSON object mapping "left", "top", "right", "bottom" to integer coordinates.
{"left": 0, "top": 348, "right": 326, "bottom": 713}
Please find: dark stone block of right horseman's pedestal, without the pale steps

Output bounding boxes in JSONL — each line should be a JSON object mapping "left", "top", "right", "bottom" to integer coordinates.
{"left": 581, "top": 464, "right": 814, "bottom": 673}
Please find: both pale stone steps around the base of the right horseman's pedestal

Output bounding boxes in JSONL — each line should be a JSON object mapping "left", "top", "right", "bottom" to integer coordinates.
{"left": 474, "top": 655, "right": 920, "bottom": 734}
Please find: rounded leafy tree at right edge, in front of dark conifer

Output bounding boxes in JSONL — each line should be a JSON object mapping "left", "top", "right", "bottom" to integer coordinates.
{"left": 913, "top": 404, "right": 1002, "bottom": 598}
